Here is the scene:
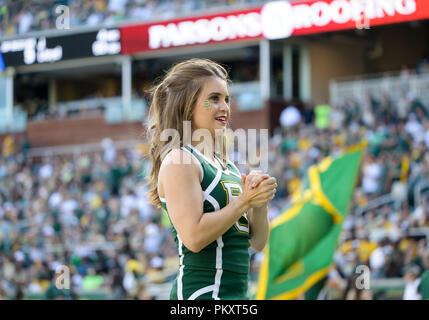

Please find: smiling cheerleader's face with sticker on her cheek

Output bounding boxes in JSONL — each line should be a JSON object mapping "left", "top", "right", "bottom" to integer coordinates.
{"left": 192, "top": 76, "right": 231, "bottom": 138}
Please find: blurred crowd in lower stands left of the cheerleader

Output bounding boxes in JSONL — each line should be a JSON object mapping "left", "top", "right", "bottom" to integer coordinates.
{"left": 0, "top": 138, "right": 177, "bottom": 299}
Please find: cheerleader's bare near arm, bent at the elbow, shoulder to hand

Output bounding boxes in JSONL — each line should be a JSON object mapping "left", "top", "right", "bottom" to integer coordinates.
{"left": 159, "top": 149, "right": 273, "bottom": 252}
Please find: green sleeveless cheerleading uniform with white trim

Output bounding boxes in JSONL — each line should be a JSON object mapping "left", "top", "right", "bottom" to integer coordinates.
{"left": 160, "top": 145, "right": 250, "bottom": 300}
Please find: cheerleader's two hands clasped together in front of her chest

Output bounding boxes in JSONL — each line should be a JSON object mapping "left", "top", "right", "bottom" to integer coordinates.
{"left": 239, "top": 171, "right": 277, "bottom": 208}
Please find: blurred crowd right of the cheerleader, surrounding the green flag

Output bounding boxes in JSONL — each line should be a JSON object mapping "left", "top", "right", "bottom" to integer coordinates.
{"left": 260, "top": 89, "right": 429, "bottom": 299}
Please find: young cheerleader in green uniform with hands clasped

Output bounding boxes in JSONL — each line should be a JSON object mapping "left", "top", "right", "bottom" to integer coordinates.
{"left": 148, "top": 59, "right": 277, "bottom": 300}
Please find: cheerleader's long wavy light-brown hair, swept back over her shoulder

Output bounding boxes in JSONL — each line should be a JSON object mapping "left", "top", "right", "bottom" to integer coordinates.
{"left": 146, "top": 59, "right": 230, "bottom": 207}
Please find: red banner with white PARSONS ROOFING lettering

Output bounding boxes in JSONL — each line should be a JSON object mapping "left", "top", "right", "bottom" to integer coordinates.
{"left": 120, "top": 0, "right": 429, "bottom": 54}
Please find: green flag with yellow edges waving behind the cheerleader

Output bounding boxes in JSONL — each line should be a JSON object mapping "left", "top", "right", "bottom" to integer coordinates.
{"left": 256, "top": 141, "right": 366, "bottom": 299}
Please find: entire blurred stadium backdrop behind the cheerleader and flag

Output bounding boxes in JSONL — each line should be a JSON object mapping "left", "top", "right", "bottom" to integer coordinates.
{"left": 0, "top": 0, "right": 429, "bottom": 299}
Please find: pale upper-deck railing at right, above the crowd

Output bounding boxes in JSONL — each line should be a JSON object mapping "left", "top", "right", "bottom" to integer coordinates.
{"left": 329, "top": 73, "right": 429, "bottom": 106}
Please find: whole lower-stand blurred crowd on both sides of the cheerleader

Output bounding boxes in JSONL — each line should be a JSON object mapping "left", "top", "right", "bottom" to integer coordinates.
{"left": 0, "top": 86, "right": 429, "bottom": 299}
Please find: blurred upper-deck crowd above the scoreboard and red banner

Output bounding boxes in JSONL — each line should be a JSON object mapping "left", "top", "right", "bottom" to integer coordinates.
{"left": 0, "top": 0, "right": 264, "bottom": 37}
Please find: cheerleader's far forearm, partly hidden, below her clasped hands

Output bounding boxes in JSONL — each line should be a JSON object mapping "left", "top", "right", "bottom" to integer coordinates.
{"left": 247, "top": 203, "right": 270, "bottom": 251}
